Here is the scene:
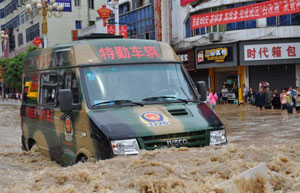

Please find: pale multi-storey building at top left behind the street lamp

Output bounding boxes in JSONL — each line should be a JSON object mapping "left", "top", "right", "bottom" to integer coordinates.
{"left": 0, "top": 0, "right": 104, "bottom": 57}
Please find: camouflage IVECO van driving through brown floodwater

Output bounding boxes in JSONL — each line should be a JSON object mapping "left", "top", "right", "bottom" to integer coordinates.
{"left": 21, "top": 36, "right": 227, "bottom": 165}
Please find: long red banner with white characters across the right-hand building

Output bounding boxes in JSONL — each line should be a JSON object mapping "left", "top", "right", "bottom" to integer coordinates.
{"left": 191, "top": 0, "right": 300, "bottom": 29}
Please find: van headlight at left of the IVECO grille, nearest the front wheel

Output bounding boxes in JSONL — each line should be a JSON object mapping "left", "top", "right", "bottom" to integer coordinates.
{"left": 111, "top": 139, "right": 140, "bottom": 155}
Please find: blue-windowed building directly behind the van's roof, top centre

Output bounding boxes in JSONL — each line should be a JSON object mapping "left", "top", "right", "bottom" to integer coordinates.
{"left": 81, "top": 0, "right": 172, "bottom": 43}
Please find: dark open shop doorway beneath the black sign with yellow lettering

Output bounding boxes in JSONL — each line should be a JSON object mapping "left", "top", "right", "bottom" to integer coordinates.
{"left": 215, "top": 68, "right": 238, "bottom": 102}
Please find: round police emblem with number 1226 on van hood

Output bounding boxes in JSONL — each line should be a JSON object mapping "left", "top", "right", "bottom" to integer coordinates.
{"left": 140, "top": 112, "right": 169, "bottom": 127}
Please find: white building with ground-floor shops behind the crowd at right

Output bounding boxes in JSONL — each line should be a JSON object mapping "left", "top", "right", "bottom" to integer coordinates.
{"left": 171, "top": 0, "right": 300, "bottom": 100}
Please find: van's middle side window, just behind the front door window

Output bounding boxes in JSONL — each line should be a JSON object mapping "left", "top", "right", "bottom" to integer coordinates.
{"left": 40, "top": 73, "right": 58, "bottom": 106}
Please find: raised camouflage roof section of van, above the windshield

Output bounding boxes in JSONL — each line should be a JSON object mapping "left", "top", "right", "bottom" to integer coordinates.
{"left": 25, "top": 39, "right": 179, "bottom": 70}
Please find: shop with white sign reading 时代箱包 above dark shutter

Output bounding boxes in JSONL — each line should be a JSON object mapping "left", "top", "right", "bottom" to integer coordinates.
{"left": 240, "top": 39, "right": 300, "bottom": 90}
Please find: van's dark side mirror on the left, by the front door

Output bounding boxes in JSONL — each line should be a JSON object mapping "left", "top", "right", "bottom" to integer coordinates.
{"left": 58, "top": 89, "right": 73, "bottom": 112}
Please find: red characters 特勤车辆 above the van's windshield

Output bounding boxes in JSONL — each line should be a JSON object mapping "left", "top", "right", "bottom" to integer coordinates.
{"left": 98, "top": 46, "right": 161, "bottom": 61}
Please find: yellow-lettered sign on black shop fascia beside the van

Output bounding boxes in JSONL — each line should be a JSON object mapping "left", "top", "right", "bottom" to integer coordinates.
{"left": 197, "top": 47, "right": 232, "bottom": 64}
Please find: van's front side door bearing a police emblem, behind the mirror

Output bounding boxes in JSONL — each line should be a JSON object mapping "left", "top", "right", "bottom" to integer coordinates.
{"left": 60, "top": 69, "right": 82, "bottom": 165}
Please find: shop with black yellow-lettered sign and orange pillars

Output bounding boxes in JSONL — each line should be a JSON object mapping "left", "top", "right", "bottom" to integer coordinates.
{"left": 195, "top": 43, "right": 244, "bottom": 100}
